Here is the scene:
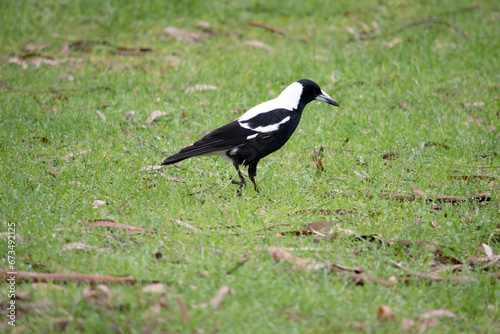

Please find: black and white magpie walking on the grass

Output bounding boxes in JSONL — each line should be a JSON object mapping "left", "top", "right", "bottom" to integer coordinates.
{"left": 161, "top": 79, "right": 339, "bottom": 194}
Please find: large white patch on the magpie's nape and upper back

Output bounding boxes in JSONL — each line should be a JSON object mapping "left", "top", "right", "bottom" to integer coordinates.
{"left": 238, "top": 82, "right": 304, "bottom": 124}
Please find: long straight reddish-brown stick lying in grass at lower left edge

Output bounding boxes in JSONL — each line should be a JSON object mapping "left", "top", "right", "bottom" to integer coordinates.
{"left": 0, "top": 268, "right": 135, "bottom": 283}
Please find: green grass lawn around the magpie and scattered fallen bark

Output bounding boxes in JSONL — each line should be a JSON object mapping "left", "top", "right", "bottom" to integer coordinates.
{"left": 0, "top": 0, "right": 500, "bottom": 333}
